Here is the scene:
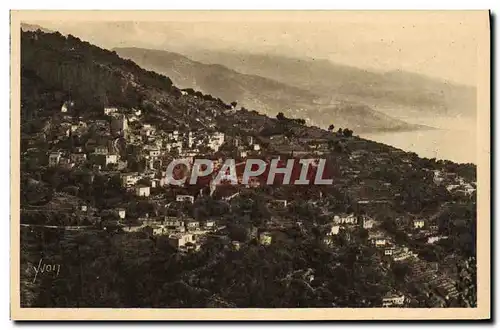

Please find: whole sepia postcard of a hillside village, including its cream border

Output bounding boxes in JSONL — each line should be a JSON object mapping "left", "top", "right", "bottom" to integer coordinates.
{"left": 10, "top": 10, "right": 491, "bottom": 320}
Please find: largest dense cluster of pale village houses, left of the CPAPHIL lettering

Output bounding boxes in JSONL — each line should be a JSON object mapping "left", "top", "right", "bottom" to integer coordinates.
{"left": 44, "top": 102, "right": 261, "bottom": 197}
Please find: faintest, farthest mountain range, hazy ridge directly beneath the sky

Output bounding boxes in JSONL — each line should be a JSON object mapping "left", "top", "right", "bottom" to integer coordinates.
{"left": 188, "top": 50, "right": 476, "bottom": 116}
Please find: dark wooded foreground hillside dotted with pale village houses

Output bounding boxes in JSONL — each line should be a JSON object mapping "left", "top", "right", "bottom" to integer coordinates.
{"left": 21, "top": 31, "right": 476, "bottom": 307}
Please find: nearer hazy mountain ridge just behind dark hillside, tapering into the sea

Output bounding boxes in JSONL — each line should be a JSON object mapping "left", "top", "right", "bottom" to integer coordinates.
{"left": 113, "top": 48, "right": 430, "bottom": 132}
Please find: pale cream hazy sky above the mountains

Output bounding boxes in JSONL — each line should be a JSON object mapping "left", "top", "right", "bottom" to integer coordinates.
{"left": 33, "top": 11, "right": 484, "bottom": 85}
